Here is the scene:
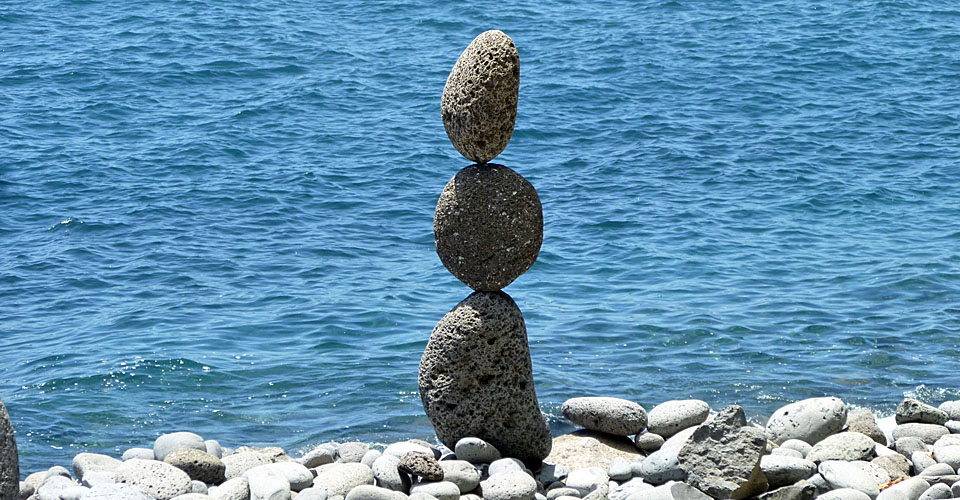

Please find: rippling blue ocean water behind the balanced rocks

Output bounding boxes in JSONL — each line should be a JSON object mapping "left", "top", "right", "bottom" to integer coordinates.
{"left": 0, "top": 0, "right": 960, "bottom": 475}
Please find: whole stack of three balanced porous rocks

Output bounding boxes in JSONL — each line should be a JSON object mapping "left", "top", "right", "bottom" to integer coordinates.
{"left": 419, "top": 30, "right": 551, "bottom": 468}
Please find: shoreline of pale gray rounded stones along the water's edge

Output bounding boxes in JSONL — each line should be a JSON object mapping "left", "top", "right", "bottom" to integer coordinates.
{"left": 0, "top": 397, "right": 960, "bottom": 500}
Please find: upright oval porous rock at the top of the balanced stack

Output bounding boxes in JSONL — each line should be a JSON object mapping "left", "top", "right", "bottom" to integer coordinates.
{"left": 440, "top": 30, "right": 520, "bottom": 163}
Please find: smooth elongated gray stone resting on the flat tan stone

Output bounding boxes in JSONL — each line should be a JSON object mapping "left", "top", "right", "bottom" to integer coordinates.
{"left": 560, "top": 397, "right": 647, "bottom": 436}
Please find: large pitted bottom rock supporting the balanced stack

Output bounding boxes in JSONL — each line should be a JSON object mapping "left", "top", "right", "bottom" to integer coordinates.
{"left": 419, "top": 292, "right": 552, "bottom": 469}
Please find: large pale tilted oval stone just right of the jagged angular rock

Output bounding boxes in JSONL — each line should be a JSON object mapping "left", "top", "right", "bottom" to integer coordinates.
{"left": 766, "top": 398, "right": 847, "bottom": 445}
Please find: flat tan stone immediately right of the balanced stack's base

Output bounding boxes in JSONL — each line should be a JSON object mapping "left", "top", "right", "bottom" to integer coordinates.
{"left": 544, "top": 430, "right": 644, "bottom": 471}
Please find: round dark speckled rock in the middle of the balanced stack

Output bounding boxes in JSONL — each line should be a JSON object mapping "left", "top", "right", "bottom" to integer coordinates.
{"left": 433, "top": 164, "right": 543, "bottom": 292}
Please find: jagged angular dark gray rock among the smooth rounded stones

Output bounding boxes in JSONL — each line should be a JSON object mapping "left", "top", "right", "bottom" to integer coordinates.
{"left": 678, "top": 405, "right": 768, "bottom": 500}
